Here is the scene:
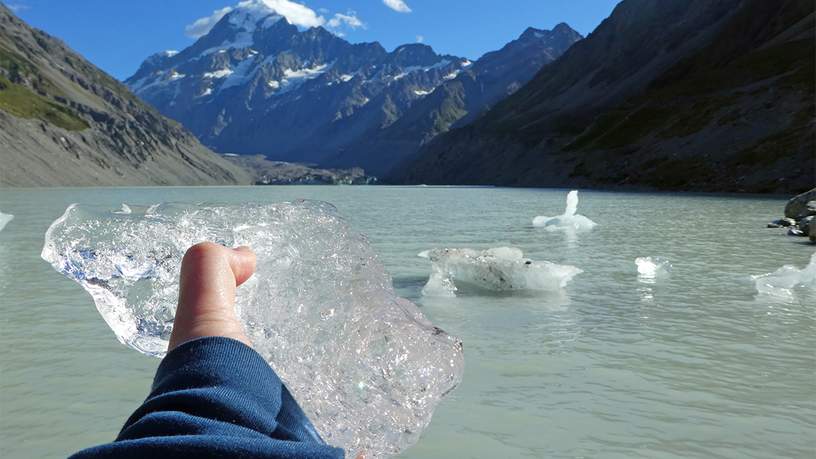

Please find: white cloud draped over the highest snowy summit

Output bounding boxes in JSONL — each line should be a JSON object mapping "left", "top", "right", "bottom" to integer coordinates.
{"left": 184, "top": 0, "right": 330, "bottom": 38}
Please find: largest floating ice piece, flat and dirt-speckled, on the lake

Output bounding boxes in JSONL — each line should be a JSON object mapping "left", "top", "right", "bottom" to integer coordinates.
{"left": 419, "top": 247, "right": 583, "bottom": 297}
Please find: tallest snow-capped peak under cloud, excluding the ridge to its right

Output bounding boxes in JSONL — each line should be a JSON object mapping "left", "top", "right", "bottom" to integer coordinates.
{"left": 126, "top": 0, "right": 471, "bottom": 166}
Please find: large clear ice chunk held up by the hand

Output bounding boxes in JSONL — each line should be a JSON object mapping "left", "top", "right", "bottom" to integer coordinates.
{"left": 42, "top": 202, "right": 464, "bottom": 458}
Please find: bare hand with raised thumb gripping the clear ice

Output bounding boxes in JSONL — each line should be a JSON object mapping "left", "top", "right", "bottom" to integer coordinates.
{"left": 167, "top": 242, "right": 255, "bottom": 352}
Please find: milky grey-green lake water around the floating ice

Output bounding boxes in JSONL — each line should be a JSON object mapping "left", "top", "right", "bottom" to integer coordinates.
{"left": 0, "top": 187, "right": 816, "bottom": 459}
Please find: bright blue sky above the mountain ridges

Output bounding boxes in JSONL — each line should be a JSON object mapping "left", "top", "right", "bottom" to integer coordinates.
{"left": 1, "top": 0, "right": 618, "bottom": 79}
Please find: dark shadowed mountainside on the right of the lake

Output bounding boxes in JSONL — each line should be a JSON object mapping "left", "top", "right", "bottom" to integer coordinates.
{"left": 393, "top": 0, "right": 816, "bottom": 193}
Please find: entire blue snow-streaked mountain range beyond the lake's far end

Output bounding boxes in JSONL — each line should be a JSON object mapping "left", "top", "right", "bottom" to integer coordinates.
{"left": 126, "top": 1, "right": 580, "bottom": 175}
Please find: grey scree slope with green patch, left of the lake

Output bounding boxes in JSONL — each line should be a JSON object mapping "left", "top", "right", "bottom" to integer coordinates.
{"left": 0, "top": 4, "right": 249, "bottom": 186}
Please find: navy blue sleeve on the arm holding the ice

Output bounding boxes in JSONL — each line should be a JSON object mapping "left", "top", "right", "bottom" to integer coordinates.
{"left": 71, "top": 338, "right": 343, "bottom": 459}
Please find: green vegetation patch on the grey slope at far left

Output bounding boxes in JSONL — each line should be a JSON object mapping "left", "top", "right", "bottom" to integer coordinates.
{"left": 0, "top": 76, "right": 90, "bottom": 131}
